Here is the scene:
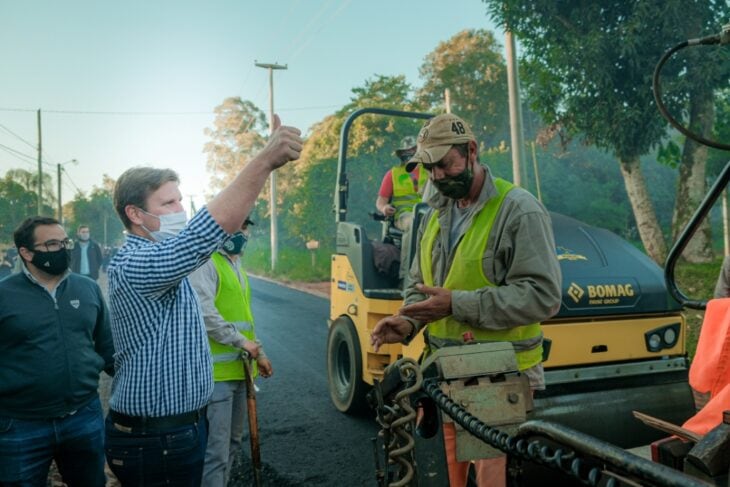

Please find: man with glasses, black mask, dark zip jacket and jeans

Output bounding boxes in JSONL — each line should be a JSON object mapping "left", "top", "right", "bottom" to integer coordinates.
{"left": 0, "top": 216, "right": 114, "bottom": 487}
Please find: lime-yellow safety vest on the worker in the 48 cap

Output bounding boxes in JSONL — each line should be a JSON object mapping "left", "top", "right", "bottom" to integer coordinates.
{"left": 421, "top": 179, "right": 542, "bottom": 370}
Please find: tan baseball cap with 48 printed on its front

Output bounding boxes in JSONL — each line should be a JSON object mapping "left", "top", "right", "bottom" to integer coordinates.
{"left": 405, "top": 113, "right": 476, "bottom": 172}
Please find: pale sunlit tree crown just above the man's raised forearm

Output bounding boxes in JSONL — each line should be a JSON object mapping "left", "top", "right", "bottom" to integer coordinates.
{"left": 203, "top": 97, "right": 268, "bottom": 195}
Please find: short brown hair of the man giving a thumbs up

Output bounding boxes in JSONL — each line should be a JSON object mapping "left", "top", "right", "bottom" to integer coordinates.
{"left": 114, "top": 167, "right": 180, "bottom": 230}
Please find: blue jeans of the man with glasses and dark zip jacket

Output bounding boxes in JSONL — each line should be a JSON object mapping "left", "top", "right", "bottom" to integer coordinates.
{"left": 0, "top": 397, "right": 106, "bottom": 487}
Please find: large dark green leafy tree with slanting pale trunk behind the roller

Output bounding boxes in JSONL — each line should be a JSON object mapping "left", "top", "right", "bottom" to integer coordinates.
{"left": 485, "top": 0, "right": 724, "bottom": 262}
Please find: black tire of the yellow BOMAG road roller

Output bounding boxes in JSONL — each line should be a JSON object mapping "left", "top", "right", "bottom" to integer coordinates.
{"left": 327, "top": 316, "right": 369, "bottom": 414}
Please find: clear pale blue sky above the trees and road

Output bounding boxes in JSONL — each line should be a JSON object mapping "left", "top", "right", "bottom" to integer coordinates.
{"left": 0, "top": 0, "right": 503, "bottom": 205}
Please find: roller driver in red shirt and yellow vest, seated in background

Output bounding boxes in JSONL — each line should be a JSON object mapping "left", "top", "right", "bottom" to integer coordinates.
{"left": 375, "top": 136, "right": 428, "bottom": 232}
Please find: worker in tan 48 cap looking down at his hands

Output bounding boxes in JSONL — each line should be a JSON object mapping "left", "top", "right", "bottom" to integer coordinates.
{"left": 371, "top": 114, "right": 561, "bottom": 487}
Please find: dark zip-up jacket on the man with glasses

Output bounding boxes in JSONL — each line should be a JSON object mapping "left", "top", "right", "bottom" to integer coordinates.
{"left": 0, "top": 272, "right": 114, "bottom": 419}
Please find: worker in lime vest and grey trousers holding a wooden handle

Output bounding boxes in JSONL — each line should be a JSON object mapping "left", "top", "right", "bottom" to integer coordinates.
{"left": 190, "top": 218, "right": 273, "bottom": 486}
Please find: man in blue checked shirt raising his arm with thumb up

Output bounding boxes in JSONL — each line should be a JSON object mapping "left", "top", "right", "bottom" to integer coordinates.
{"left": 106, "top": 116, "right": 302, "bottom": 486}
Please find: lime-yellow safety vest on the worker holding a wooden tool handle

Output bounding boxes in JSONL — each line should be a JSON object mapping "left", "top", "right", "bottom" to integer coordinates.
{"left": 208, "top": 252, "right": 257, "bottom": 382}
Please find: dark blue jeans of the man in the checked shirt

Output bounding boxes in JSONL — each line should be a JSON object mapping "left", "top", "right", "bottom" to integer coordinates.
{"left": 105, "top": 416, "right": 208, "bottom": 487}
